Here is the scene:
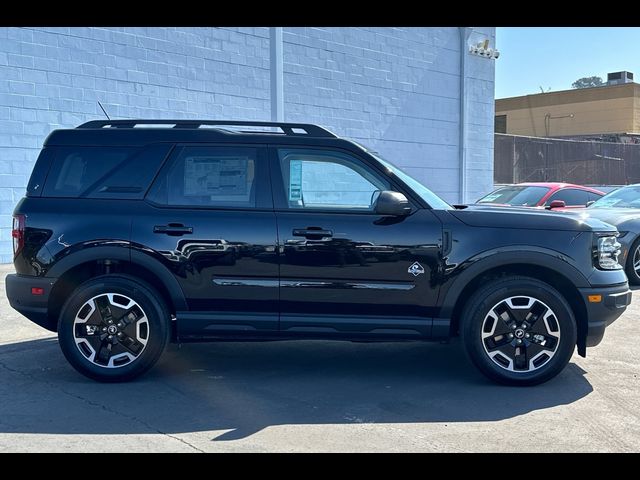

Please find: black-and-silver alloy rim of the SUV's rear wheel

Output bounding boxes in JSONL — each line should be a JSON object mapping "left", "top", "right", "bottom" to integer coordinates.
{"left": 73, "top": 293, "right": 149, "bottom": 368}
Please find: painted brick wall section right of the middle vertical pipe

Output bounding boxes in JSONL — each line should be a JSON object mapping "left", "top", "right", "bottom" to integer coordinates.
{"left": 284, "top": 27, "right": 495, "bottom": 202}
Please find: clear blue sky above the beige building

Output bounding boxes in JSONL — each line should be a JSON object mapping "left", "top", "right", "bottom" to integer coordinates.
{"left": 496, "top": 27, "right": 640, "bottom": 98}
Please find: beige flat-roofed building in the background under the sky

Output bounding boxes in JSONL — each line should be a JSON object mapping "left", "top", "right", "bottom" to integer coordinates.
{"left": 495, "top": 72, "right": 640, "bottom": 137}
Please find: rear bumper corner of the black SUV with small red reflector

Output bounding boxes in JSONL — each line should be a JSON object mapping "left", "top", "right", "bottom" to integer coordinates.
{"left": 6, "top": 273, "right": 57, "bottom": 332}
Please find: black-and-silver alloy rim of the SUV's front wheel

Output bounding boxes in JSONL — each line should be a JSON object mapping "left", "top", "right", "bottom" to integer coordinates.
{"left": 481, "top": 295, "right": 560, "bottom": 373}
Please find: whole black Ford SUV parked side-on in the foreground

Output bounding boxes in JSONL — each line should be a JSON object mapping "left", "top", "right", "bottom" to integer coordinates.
{"left": 6, "top": 120, "right": 631, "bottom": 384}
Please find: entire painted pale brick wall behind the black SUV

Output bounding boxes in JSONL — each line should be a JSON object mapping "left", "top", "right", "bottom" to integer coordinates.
{"left": 0, "top": 27, "right": 494, "bottom": 262}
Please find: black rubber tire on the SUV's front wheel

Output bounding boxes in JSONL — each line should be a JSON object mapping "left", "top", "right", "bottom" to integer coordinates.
{"left": 461, "top": 276, "right": 577, "bottom": 385}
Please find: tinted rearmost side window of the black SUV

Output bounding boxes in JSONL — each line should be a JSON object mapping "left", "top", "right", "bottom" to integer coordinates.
{"left": 43, "top": 145, "right": 169, "bottom": 198}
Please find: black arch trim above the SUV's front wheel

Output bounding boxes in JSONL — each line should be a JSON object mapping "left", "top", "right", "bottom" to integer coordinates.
{"left": 439, "top": 246, "right": 591, "bottom": 318}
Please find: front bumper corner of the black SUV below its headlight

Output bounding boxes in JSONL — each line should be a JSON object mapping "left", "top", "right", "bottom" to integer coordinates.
{"left": 579, "top": 283, "right": 631, "bottom": 348}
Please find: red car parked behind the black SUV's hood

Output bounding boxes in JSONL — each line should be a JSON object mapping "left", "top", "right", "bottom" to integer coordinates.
{"left": 477, "top": 182, "right": 604, "bottom": 208}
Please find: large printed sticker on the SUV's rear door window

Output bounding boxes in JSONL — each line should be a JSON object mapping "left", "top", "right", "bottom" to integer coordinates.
{"left": 184, "top": 156, "right": 249, "bottom": 199}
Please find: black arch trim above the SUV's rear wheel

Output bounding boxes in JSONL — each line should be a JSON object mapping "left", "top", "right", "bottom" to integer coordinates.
{"left": 46, "top": 246, "right": 188, "bottom": 310}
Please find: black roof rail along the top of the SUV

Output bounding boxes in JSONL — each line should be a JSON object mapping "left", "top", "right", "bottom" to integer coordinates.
{"left": 77, "top": 120, "right": 337, "bottom": 138}
